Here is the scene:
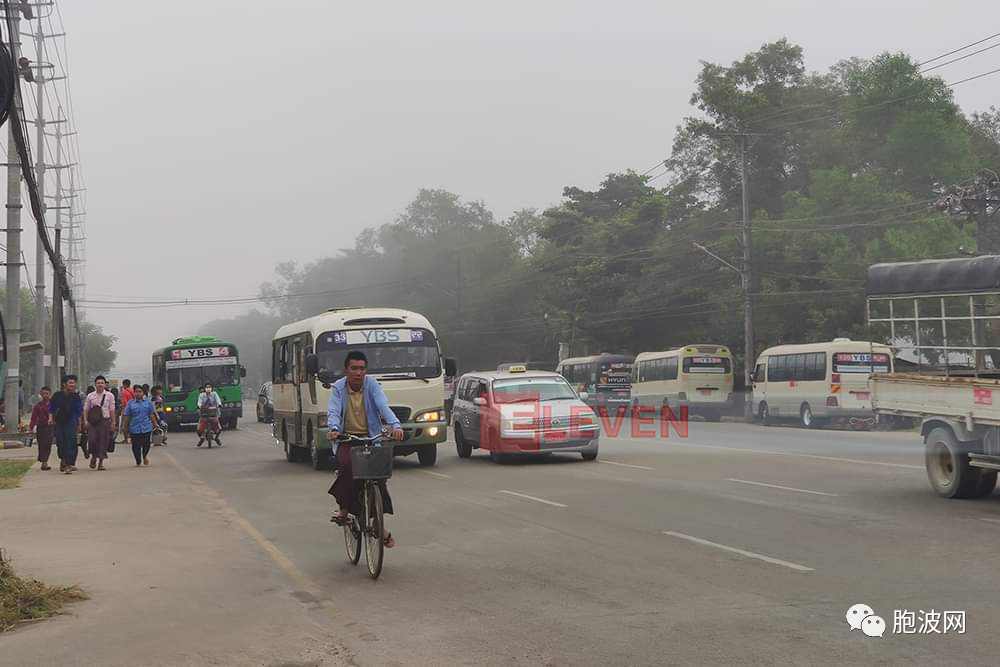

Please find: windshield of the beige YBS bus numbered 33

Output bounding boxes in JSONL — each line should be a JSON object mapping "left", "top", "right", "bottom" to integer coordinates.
{"left": 316, "top": 329, "right": 441, "bottom": 380}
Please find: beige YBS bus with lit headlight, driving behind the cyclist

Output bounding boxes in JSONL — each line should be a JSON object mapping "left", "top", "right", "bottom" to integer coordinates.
{"left": 271, "top": 308, "right": 454, "bottom": 470}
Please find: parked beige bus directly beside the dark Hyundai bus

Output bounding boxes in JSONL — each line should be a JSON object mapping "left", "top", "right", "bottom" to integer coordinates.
{"left": 632, "top": 344, "right": 733, "bottom": 421}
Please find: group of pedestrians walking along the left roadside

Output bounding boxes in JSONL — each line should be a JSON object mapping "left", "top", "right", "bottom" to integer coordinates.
{"left": 29, "top": 375, "right": 166, "bottom": 475}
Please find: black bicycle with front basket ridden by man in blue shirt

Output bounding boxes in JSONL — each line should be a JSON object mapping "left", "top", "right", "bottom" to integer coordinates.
{"left": 337, "top": 433, "right": 393, "bottom": 579}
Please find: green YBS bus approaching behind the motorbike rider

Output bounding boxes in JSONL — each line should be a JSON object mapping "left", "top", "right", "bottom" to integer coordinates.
{"left": 153, "top": 336, "right": 246, "bottom": 428}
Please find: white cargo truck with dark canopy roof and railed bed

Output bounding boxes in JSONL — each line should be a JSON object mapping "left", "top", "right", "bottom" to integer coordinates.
{"left": 867, "top": 255, "right": 1000, "bottom": 498}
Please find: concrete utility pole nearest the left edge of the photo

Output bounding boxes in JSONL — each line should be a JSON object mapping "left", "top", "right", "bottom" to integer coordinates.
{"left": 4, "top": 9, "right": 22, "bottom": 433}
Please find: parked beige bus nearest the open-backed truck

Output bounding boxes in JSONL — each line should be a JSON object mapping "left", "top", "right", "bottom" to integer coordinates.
{"left": 753, "top": 338, "right": 892, "bottom": 428}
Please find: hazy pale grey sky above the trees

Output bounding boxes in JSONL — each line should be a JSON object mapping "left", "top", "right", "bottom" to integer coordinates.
{"left": 17, "top": 0, "right": 1000, "bottom": 376}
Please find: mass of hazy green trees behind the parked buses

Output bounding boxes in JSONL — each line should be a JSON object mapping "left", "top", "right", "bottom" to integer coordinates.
{"left": 206, "top": 40, "right": 1000, "bottom": 380}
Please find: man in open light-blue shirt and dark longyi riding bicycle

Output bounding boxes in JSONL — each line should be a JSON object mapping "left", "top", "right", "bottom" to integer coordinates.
{"left": 326, "top": 350, "right": 403, "bottom": 548}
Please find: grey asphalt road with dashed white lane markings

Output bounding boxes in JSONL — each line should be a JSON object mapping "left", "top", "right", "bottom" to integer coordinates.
{"left": 150, "top": 414, "right": 1000, "bottom": 665}
